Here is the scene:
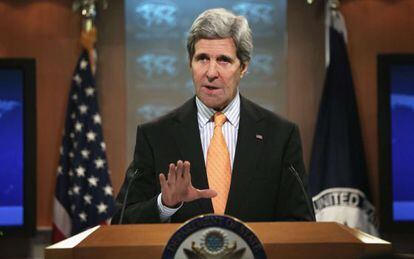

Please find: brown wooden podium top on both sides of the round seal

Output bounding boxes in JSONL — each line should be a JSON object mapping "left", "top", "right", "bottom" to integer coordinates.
{"left": 45, "top": 222, "right": 392, "bottom": 259}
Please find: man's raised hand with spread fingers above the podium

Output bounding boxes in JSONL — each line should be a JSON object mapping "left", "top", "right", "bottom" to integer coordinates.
{"left": 159, "top": 160, "right": 217, "bottom": 208}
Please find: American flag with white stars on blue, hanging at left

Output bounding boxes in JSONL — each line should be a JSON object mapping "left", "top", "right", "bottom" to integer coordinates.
{"left": 53, "top": 50, "right": 114, "bottom": 242}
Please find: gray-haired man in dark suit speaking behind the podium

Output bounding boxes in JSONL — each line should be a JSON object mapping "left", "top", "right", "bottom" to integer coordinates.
{"left": 112, "top": 9, "right": 313, "bottom": 223}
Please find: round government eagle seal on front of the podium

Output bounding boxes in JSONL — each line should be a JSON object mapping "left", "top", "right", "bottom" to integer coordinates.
{"left": 162, "top": 214, "right": 266, "bottom": 259}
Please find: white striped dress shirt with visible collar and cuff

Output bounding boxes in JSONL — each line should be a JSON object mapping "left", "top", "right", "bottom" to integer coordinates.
{"left": 157, "top": 92, "right": 240, "bottom": 222}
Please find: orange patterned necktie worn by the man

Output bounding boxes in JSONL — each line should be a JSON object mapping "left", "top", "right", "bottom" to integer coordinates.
{"left": 207, "top": 112, "right": 231, "bottom": 214}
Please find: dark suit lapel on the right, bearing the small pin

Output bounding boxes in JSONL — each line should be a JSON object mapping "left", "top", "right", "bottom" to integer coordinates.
{"left": 226, "top": 96, "right": 265, "bottom": 216}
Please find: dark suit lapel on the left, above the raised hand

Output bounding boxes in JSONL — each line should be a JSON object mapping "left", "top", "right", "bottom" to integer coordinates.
{"left": 173, "top": 98, "right": 213, "bottom": 213}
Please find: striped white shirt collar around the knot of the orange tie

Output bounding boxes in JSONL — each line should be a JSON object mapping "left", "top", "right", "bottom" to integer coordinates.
{"left": 196, "top": 91, "right": 240, "bottom": 127}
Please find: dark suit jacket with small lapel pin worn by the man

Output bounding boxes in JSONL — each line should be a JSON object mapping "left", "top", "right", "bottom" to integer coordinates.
{"left": 112, "top": 97, "right": 312, "bottom": 223}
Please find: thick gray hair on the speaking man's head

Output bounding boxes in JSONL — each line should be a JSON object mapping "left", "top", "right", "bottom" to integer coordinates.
{"left": 187, "top": 8, "right": 253, "bottom": 65}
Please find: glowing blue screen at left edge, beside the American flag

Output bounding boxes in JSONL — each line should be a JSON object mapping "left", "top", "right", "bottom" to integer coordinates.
{"left": 0, "top": 69, "right": 24, "bottom": 226}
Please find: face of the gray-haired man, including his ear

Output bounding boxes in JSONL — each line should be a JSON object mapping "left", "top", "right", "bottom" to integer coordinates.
{"left": 190, "top": 38, "right": 248, "bottom": 111}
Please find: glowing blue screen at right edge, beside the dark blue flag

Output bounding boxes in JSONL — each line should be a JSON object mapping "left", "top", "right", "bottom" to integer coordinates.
{"left": 390, "top": 65, "right": 414, "bottom": 221}
